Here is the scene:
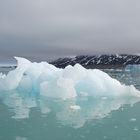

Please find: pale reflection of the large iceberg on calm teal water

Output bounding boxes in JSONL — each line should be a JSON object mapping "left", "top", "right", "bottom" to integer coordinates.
{"left": 1, "top": 91, "right": 140, "bottom": 128}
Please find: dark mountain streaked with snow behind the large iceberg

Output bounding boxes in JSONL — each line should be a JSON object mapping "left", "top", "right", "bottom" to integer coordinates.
{"left": 50, "top": 54, "right": 140, "bottom": 68}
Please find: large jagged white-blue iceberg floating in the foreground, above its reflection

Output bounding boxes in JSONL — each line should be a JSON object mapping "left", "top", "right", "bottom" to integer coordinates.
{"left": 0, "top": 57, "right": 140, "bottom": 99}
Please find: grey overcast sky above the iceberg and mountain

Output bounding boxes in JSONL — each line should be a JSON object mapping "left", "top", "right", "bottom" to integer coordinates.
{"left": 0, "top": 0, "right": 140, "bottom": 60}
